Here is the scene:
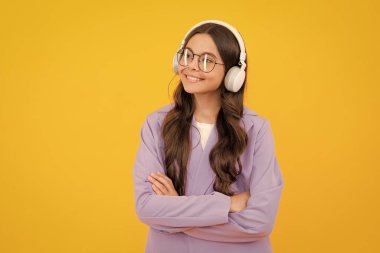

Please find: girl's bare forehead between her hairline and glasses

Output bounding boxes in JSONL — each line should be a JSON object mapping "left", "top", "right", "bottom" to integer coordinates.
{"left": 186, "top": 33, "right": 221, "bottom": 59}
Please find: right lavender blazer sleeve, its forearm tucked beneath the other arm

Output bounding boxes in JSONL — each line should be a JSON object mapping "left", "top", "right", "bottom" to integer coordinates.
{"left": 184, "top": 120, "right": 284, "bottom": 242}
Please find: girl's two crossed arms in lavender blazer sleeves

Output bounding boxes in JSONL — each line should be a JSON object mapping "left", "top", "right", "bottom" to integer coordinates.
{"left": 133, "top": 114, "right": 283, "bottom": 242}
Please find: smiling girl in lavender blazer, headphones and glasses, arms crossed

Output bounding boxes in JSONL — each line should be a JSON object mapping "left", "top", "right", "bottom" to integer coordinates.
{"left": 133, "top": 20, "right": 284, "bottom": 253}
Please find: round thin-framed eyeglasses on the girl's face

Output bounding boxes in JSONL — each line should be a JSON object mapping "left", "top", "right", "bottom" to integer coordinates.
{"left": 177, "top": 48, "right": 224, "bottom": 73}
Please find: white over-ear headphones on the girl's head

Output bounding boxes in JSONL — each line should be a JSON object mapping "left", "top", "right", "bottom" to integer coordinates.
{"left": 173, "top": 20, "right": 246, "bottom": 92}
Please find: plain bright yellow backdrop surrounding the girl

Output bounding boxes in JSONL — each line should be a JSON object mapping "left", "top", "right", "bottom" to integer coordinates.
{"left": 0, "top": 0, "right": 380, "bottom": 253}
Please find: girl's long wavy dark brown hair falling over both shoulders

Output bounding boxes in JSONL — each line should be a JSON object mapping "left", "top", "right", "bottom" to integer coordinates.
{"left": 161, "top": 23, "right": 248, "bottom": 196}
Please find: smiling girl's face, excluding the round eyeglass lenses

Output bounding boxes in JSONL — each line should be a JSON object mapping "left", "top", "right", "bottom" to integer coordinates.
{"left": 178, "top": 33, "right": 224, "bottom": 94}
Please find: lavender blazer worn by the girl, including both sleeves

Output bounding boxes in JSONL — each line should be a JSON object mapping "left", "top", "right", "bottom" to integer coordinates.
{"left": 132, "top": 103, "right": 284, "bottom": 253}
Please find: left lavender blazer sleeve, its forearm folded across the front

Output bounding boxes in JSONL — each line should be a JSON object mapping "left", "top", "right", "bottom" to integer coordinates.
{"left": 132, "top": 114, "right": 231, "bottom": 233}
